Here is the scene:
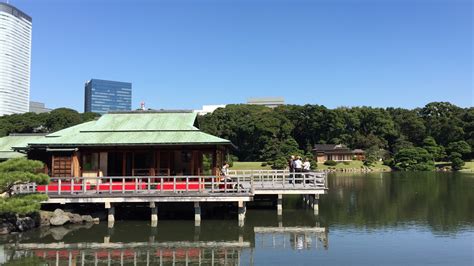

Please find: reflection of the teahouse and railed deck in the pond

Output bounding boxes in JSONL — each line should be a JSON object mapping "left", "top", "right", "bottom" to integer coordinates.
{"left": 0, "top": 221, "right": 328, "bottom": 265}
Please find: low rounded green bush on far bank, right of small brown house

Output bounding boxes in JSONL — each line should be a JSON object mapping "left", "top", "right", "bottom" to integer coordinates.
{"left": 393, "top": 147, "right": 435, "bottom": 171}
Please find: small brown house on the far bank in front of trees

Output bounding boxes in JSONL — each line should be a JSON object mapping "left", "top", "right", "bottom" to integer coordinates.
{"left": 313, "top": 144, "right": 365, "bottom": 163}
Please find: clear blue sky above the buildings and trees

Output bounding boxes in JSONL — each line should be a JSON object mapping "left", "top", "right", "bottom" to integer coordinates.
{"left": 10, "top": 0, "right": 474, "bottom": 112}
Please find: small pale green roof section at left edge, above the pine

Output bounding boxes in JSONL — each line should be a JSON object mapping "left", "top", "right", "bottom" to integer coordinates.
{"left": 0, "top": 134, "right": 44, "bottom": 160}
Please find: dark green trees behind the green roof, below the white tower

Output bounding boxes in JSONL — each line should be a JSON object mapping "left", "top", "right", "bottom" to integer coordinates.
{"left": 0, "top": 108, "right": 98, "bottom": 137}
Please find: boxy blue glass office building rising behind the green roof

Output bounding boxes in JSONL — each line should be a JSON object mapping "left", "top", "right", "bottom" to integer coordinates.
{"left": 84, "top": 79, "right": 132, "bottom": 114}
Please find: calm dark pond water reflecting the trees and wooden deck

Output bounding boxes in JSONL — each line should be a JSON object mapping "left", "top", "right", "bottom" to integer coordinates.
{"left": 0, "top": 173, "right": 474, "bottom": 265}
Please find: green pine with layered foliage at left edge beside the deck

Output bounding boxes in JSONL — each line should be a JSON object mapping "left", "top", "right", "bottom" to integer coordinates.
{"left": 0, "top": 158, "right": 49, "bottom": 214}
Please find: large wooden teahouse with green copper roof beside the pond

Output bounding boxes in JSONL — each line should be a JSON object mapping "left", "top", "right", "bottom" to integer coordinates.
{"left": 14, "top": 111, "right": 232, "bottom": 177}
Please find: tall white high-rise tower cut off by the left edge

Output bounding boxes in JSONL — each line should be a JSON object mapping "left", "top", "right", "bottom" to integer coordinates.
{"left": 0, "top": 2, "right": 32, "bottom": 116}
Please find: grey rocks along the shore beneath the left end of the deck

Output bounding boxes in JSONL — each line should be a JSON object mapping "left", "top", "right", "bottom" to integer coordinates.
{"left": 0, "top": 209, "right": 100, "bottom": 235}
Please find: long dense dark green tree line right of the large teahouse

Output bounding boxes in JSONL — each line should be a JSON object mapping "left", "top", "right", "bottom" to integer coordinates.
{"left": 199, "top": 102, "right": 474, "bottom": 170}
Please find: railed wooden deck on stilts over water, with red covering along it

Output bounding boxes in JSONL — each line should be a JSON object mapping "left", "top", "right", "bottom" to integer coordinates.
{"left": 15, "top": 170, "right": 328, "bottom": 224}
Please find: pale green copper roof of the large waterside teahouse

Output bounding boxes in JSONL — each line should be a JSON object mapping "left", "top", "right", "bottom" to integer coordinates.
{"left": 25, "top": 112, "right": 231, "bottom": 147}
